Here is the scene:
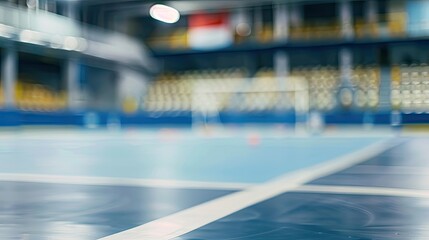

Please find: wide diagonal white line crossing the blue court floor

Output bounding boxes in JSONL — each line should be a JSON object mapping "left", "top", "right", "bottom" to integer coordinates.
{"left": 101, "top": 141, "right": 396, "bottom": 240}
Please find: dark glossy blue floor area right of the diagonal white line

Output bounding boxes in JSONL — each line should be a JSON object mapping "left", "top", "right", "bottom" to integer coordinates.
{"left": 176, "top": 139, "right": 429, "bottom": 240}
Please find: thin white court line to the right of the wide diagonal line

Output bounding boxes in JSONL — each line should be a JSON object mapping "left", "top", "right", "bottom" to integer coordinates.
{"left": 293, "top": 185, "right": 429, "bottom": 198}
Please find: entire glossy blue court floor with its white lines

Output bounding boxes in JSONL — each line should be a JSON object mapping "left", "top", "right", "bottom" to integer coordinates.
{"left": 0, "top": 131, "right": 429, "bottom": 240}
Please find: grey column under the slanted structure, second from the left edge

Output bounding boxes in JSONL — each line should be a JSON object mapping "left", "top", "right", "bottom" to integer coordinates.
{"left": 65, "top": 58, "right": 79, "bottom": 110}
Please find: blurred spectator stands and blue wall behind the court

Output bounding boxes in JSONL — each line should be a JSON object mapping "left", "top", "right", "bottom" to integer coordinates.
{"left": 0, "top": 0, "right": 429, "bottom": 132}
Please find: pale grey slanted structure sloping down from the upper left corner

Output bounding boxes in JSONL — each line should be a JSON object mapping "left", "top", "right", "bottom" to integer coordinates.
{"left": 0, "top": 4, "right": 153, "bottom": 69}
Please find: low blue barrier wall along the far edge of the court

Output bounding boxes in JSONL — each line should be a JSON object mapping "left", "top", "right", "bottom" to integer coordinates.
{"left": 0, "top": 110, "right": 429, "bottom": 127}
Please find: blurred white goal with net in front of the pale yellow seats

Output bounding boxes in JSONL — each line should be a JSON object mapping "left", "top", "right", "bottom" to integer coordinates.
{"left": 191, "top": 77, "right": 310, "bottom": 131}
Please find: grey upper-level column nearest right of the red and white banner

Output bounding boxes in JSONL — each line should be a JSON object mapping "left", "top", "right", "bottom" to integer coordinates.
{"left": 274, "top": 4, "right": 289, "bottom": 40}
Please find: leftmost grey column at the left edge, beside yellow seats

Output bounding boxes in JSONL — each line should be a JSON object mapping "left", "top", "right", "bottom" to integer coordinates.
{"left": 2, "top": 48, "right": 18, "bottom": 108}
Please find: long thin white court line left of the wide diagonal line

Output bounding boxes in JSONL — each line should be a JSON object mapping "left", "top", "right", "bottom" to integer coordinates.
{"left": 0, "top": 173, "right": 250, "bottom": 190}
